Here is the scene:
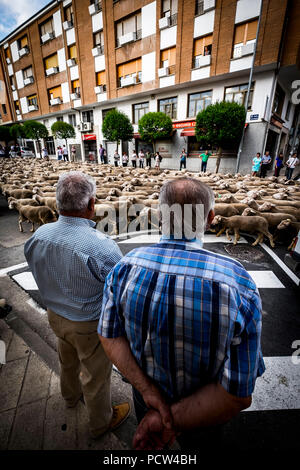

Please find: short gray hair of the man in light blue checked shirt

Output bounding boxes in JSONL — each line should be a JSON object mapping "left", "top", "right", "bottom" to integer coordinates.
{"left": 56, "top": 171, "right": 96, "bottom": 212}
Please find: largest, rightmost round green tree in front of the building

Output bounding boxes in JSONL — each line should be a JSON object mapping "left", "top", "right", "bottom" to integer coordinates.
{"left": 196, "top": 101, "right": 246, "bottom": 173}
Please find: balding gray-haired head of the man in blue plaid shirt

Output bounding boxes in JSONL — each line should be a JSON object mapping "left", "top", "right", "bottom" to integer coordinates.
{"left": 159, "top": 177, "right": 215, "bottom": 239}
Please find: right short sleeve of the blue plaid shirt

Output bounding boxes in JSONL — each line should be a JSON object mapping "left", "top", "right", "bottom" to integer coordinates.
{"left": 219, "top": 291, "right": 265, "bottom": 397}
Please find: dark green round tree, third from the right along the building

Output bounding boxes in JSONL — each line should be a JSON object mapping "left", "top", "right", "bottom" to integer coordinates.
{"left": 102, "top": 109, "right": 133, "bottom": 151}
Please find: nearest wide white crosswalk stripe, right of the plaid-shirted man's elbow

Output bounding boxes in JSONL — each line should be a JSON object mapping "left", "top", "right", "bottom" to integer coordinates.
{"left": 244, "top": 356, "right": 300, "bottom": 411}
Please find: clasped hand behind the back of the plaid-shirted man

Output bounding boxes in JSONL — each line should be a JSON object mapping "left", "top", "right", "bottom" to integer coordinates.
{"left": 133, "top": 410, "right": 178, "bottom": 450}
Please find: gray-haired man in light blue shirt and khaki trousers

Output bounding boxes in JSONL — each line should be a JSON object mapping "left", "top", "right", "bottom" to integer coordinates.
{"left": 24, "top": 171, "right": 130, "bottom": 438}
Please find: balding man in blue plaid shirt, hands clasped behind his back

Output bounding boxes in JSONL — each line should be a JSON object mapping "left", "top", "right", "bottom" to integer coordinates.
{"left": 98, "top": 178, "right": 265, "bottom": 450}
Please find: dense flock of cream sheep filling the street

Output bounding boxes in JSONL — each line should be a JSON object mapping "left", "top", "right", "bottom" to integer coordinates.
{"left": 0, "top": 158, "right": 300, "bottom": 252}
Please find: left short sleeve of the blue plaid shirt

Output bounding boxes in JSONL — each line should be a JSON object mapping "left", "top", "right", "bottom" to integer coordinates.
{"left": 98, "top": 265, "right": 126, "bottom": 338}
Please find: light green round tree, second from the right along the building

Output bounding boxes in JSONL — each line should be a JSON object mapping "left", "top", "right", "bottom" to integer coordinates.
{"left": 139, "top": 111, "right": 173, "bottom": 153}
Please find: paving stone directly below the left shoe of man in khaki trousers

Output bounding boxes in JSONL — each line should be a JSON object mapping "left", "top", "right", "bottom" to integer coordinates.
{"left": 43, "top": 394, "right": 77, "bottom": 450}
